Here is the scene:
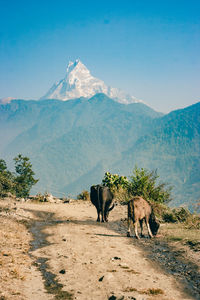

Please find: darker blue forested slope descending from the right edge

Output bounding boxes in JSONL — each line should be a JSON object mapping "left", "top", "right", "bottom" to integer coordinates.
{"left": 114, "top": 103, "right": 200, "bottom": 208}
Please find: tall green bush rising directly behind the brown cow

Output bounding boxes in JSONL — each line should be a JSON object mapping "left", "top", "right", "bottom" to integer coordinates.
{"left": 128, "top": 166, "right": 172, "bottom": 203}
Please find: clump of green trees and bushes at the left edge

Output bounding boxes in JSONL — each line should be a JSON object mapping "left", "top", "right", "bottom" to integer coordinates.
{"left": 0, "top": 154, "right": 38, "bottom": 197}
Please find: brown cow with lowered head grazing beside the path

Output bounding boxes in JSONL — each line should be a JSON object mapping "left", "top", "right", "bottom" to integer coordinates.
{"left": 127, "top": 196, "right": 160, "bottom": 239}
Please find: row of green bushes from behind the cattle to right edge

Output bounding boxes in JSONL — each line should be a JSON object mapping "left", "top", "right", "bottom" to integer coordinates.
{"left": 102, "top": 166, "right": 200, "bottom": 229}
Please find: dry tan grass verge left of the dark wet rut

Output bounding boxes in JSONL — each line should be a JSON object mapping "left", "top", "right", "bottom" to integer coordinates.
{"left": 0, "top": 200, "right": 31, "bottom": 299}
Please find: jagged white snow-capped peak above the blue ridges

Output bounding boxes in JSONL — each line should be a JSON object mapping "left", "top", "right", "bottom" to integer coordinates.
{"left": 41, "top": 59, "right": 142, "bottom": 104}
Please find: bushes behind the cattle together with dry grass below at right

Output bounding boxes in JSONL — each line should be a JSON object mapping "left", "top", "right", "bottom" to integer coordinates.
{"left": 102, "top": 166, "right": 200, "bottom": 247}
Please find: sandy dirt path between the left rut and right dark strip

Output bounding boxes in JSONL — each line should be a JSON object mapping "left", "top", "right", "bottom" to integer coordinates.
{"left": 18, "top": 202, "right": 199, "bottom": 300}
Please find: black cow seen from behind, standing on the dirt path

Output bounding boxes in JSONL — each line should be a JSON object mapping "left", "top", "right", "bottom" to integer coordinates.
{"left": 90, "top": 184, "right": 114, "bottom": 222}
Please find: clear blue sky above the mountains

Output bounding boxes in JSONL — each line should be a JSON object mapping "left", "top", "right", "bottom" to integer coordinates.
{"left": 0, "top": 0, "right": 200, "bottom": 112}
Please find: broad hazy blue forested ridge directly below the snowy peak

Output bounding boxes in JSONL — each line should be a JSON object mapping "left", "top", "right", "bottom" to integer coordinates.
{"left": 0, "top": 94, "right": 160, "bottom": 193}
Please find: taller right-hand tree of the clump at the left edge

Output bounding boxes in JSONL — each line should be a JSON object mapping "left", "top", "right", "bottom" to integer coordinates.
{"left": 14, "top": 154, "right": 38, "bottom": 197}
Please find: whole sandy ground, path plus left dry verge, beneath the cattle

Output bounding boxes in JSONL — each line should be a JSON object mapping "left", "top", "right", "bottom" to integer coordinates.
{"left": 0, "top": 201, "right": 199, "bottom": 300}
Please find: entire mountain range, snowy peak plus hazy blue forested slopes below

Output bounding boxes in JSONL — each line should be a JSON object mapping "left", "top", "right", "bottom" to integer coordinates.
{"left": 0, "top": 60, "right": 200, "bottom": 210}
